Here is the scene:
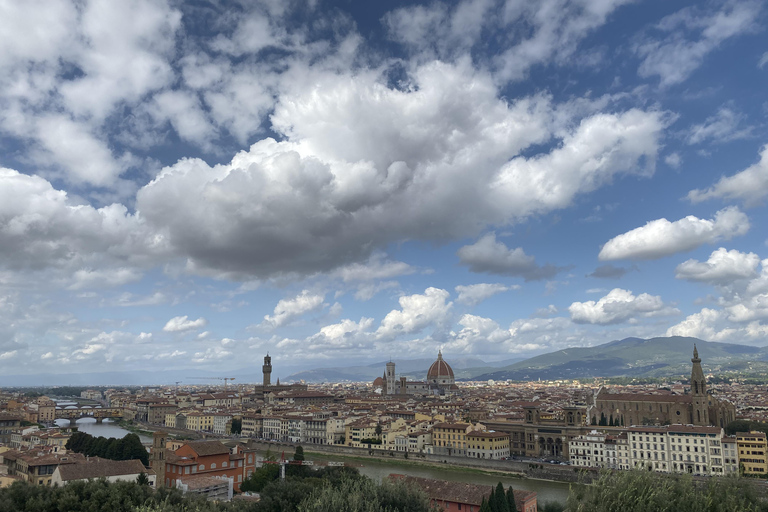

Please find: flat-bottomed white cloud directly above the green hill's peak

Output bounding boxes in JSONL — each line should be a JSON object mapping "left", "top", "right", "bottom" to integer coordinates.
{"left": 568, "top": 288, "right": 679, "bottom": 325}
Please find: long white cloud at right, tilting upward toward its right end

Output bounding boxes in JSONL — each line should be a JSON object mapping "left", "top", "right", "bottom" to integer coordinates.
{"left": 598, "top": 207, "right": 749, "bottom": 261}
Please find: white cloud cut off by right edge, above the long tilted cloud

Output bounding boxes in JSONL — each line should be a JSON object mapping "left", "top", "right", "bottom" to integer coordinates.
{"left": 688, "top": 145, "right": 768, "bottom": 206}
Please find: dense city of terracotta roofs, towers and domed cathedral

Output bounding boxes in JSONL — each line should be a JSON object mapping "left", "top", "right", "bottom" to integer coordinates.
{"left": 0, "top": 347, "right": 768, "bottom": 512}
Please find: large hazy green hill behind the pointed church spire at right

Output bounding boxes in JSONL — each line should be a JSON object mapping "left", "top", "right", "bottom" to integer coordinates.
{"left": 472, "top": 336, "right": 768, "bottom": 380}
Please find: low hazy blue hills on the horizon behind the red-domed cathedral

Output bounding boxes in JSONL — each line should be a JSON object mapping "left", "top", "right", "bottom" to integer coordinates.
{"left": 285, "top": 357, "right": 522, "bottom": 382}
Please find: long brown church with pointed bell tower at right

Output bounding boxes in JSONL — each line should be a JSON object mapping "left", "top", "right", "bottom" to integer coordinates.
{"left": 588, "top": 345, "right": 736, "bottom": 428}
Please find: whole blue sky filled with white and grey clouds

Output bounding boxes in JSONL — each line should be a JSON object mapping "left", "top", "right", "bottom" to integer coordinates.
{"left": 0, "top": 0, "right": 768, "bottom": 377}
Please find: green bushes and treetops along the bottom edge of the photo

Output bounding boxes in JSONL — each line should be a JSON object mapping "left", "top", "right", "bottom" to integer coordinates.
{"left": 0, "top": 458, "right": 768, "bottom": 512}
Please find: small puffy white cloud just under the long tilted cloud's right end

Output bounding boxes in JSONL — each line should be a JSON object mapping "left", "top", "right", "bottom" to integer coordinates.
{"left": 675, "top": 247, "right": 760, "bottom": 284}
